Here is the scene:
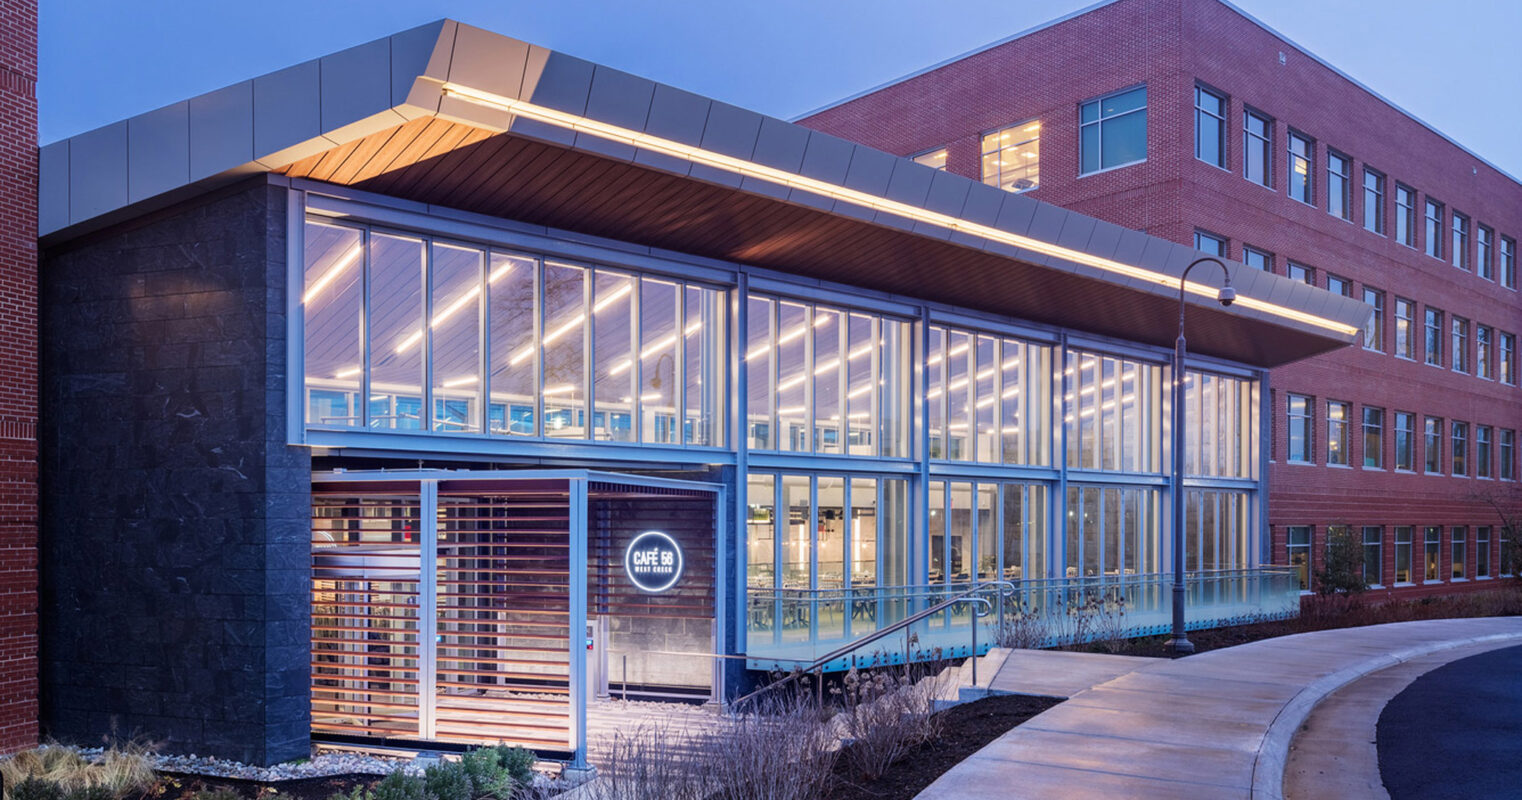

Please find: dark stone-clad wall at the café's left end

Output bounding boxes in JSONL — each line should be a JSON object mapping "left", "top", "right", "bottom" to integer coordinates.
{"left": 41, "top": 176, "right": 310, "bottom": 765}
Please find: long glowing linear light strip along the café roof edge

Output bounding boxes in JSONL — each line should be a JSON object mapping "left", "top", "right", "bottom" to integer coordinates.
{"left": 441, "top": 82, "right": 1359, "bottom": 336}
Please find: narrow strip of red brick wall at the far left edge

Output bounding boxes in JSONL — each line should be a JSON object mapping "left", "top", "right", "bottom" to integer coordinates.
{"left": 0, "top": 0, "right": 37, "bottom": 753}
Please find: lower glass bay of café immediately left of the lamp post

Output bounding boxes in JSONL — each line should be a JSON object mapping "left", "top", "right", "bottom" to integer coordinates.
{"left": 1062, "top": 484, "right": 1161, "bottom": 578}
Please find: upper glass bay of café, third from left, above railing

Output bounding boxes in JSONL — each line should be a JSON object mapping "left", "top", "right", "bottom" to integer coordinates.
{"left": 925, "top": 327, "right": 1052, "bottom": 467}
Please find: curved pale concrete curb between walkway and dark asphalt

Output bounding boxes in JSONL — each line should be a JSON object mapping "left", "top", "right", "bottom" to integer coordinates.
{"left": 1253, "top": 633, "right": 1522, "bottom": 800}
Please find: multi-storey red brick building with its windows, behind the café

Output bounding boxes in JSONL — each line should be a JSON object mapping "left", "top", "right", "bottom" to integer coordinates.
{"left": 801, "top": 0, "right": 1522, "bottom": 595}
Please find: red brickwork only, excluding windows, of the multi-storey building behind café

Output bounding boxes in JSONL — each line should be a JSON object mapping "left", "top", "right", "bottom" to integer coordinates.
{"left": 802, "top": 0, "right": 1522, "bottom": 593}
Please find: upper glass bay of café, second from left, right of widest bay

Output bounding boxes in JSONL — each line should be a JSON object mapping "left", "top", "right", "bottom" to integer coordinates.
{"left": 746, "top": 295, "right": 913, "bottom": 458}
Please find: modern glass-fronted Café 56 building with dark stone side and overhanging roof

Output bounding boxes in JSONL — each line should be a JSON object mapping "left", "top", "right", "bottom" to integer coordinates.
{"left": 40, "top": 21, "right": 1368, "bottom": 762}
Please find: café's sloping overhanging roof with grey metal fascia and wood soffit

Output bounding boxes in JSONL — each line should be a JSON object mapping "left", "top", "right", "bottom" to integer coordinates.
{"left": 40, "top": 21, "right": 1370, "bottom": 367}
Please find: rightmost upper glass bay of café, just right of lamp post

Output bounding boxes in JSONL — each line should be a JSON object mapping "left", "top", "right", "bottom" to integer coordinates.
{"left": 1184, "top": 371, "right": 1259, "bottom": 478}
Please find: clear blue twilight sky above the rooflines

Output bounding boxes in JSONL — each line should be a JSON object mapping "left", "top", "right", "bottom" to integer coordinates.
{"left": 38, "top": 0, "right": 1522, "bottom": 178}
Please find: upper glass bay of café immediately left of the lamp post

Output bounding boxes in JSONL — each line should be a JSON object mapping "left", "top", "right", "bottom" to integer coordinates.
{"left": 1062, "top": 350, "right": 1163, "bottom": 473}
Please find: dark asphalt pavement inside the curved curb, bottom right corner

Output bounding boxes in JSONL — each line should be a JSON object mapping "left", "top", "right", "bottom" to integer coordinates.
{"left": 1377, "top": 646, "right": 1522, "bottom": 800}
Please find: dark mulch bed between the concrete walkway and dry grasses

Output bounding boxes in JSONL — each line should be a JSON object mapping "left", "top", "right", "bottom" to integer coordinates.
{"left": 829, "top": 695, "right": 1061, "bottom": 800}
